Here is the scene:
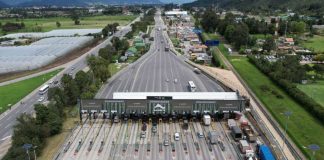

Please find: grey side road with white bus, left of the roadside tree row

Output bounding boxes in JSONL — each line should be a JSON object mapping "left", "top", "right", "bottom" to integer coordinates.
{"left": 0, "top": 17, "right": 140, "bottom": 159}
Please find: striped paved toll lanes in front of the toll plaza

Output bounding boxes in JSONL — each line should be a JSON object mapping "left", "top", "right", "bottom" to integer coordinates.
{"left": 57, "top": 115, "right": 243, "bottom": 160}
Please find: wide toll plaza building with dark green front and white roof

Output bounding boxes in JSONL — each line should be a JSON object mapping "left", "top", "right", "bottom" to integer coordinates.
{"left": 79, "top": 92, "right": 245, "bottom": 117}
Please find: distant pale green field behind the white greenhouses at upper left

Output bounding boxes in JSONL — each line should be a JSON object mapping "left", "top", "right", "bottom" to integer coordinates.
{"left": 0, "top": 15, "right": 137, "bottom": 35}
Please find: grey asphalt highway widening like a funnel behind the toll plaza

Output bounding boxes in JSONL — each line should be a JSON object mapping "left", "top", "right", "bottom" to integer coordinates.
{"left": 96, "top": 10, "right": 224, "bottom": 98}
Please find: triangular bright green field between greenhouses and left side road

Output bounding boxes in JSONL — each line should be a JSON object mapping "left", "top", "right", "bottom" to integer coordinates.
{"left": 0, "top": 69, "right": 62, "bottom": 113}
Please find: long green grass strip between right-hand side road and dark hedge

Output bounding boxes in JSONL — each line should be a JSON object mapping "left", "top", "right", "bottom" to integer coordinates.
{"left": 230, "top": 57, "right": 324, "bottom": 159}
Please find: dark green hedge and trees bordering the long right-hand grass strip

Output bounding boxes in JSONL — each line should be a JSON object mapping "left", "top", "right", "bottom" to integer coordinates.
{"left": 248, "top": 55, "right": 324, "bottom": 123}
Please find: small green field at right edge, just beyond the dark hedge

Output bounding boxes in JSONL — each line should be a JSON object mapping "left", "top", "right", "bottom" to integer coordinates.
{"left": 298, "top": 80, "right": 324, "bottom": 106}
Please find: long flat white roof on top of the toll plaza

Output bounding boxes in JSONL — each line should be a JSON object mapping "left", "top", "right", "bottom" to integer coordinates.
{"left": 113, "top": 92, "right": 240, "bottom": 100}
